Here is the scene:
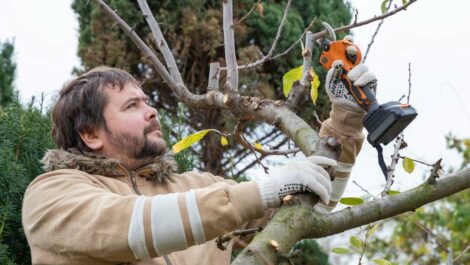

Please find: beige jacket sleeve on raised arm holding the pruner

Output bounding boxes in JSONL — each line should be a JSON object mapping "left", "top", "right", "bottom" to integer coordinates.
{"left": 316, "top": 103, "right": 365, "bottom": 212}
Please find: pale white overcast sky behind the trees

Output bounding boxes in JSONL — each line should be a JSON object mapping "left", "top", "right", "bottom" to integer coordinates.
{"left": 0, "top": 0, "right": 470, "bottom": 196}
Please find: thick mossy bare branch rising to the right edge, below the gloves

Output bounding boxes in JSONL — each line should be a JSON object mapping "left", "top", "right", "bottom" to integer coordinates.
{"left": 232, "top": 168, "right": 470, "bottom": 264}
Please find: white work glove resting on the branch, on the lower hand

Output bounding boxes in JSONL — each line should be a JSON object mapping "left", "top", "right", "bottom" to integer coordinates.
{"left": 257, "top": 156, "right": 336, "bottom": 209}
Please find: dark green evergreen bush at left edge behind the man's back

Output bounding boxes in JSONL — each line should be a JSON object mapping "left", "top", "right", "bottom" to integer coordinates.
{"left": 0, "top": 98, "right": 54, "bottom": 264}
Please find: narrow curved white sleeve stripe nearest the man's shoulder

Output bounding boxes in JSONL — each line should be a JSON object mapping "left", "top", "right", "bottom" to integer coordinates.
{"left": 127, "top": 196, "right": 150, "bottom": 260}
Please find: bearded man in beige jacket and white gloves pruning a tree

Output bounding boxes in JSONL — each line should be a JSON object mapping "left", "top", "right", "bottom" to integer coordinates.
{"left": 23, "top": 56, "right": 375, "bottom": 264}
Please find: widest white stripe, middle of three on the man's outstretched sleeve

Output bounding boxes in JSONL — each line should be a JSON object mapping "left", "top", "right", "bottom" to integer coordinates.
{"left": 151, "top": 193, "right": 188, "bottom": 256}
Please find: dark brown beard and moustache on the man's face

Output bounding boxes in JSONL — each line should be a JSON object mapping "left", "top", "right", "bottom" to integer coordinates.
{"left": 109, "top": 121, "right": 166, "bottom": 166}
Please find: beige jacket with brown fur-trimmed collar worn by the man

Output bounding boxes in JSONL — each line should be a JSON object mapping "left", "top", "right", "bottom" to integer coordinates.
{"left": 22, "top": 103, "right": 363, "bottom": 265}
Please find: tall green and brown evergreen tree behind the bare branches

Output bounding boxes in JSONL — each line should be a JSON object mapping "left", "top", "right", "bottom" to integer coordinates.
{"left": 72, "top": 0, "right": 351, "bottom": 175}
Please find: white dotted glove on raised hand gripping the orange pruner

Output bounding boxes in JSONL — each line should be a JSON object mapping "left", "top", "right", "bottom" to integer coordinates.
{"left": 325, "top": 36, "right": 377, "bottom": 111}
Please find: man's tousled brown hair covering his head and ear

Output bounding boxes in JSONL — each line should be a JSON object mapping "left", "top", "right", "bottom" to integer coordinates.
{"left": 51, "top": 66, "right": 139, "bottom": 151}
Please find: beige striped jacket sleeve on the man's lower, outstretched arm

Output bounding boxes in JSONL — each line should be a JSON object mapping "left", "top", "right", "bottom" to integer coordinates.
{"left": 23, "top": 170, "right": 264, "bottom": 262}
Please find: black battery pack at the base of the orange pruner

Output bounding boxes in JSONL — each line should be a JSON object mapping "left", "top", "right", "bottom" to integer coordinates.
{"left": 362, "top": 101, "right": 418, "bottom": 146}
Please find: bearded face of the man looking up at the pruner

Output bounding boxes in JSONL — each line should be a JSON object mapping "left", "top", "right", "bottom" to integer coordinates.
{"left": 99, "top": 83, "right": 166, "bottom": 168}
